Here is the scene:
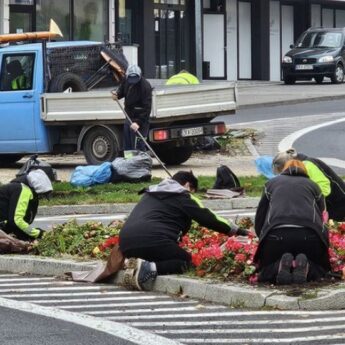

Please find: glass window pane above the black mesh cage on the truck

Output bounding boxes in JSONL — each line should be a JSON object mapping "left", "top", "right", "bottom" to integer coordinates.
{"left": 73, "top": 0, "right": 108, "bottom": 41}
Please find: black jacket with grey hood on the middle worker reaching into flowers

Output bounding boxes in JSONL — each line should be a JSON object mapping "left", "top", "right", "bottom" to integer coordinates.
{"left": 120, "top": 179, "right": 237, "bottom": 252}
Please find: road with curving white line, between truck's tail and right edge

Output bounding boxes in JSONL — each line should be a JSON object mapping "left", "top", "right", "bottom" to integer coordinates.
{"left": 219, "top": 100, "right": 345, "bottom": 175}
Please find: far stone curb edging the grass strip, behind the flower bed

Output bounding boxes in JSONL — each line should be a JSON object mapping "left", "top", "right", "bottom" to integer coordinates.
{"left": 37, "top": 197, "right": 260, "bottom": 217}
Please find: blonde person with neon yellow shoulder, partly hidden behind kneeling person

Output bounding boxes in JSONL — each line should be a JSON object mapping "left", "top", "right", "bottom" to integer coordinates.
{"left": 273, "top": 148, "right": 345, "bottom": 221}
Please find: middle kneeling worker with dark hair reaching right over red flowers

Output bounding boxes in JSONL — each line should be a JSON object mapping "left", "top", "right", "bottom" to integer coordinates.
{"left": 120, "top": 171, "right": 247, "bottom": 290}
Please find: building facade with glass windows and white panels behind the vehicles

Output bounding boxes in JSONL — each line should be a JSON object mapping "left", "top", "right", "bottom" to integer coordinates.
{"left": 0, "top": 0, "right": 345, "bottom": 80}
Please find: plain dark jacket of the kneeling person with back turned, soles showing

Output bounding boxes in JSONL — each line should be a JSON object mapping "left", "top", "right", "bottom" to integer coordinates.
{"left": 255, "top": 168, "right": 328, "bottom": 246}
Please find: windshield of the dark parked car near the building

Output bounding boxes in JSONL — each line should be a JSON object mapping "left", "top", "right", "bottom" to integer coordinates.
{"left": 296, "top": 31, "right": 342, "bottom": 48}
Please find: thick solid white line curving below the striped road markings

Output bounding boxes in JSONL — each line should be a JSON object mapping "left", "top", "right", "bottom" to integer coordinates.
{"left": 0, "top": 297, "right": 180, "bottom": 345}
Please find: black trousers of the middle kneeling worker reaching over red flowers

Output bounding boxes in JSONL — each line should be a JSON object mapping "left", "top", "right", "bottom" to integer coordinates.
{"left": 123, "top": 242, "right": 192, "bottom": 275}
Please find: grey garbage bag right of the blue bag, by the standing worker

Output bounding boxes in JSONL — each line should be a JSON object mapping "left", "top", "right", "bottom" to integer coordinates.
{"left": 111, "top": 151, "right": 152, "bottom": 182}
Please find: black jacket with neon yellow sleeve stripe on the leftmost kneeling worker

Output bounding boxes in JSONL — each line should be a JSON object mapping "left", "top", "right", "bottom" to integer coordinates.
{"left": 0, "top": 182, "right": 38, "bottom": 232}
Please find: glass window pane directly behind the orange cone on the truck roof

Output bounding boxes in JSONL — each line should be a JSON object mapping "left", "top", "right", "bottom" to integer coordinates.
{"left": 36, "top": 0, "right": 71, "bottom": 40}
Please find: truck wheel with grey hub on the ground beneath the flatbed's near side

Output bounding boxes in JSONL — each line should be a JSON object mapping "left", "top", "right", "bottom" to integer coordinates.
{"left": 83, "top": 126, "right": 120, "bottom": 165}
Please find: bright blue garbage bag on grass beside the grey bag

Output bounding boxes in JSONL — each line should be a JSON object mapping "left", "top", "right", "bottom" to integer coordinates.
{"left": 70, "top": 162, "right": 111, "bottom": 187}
